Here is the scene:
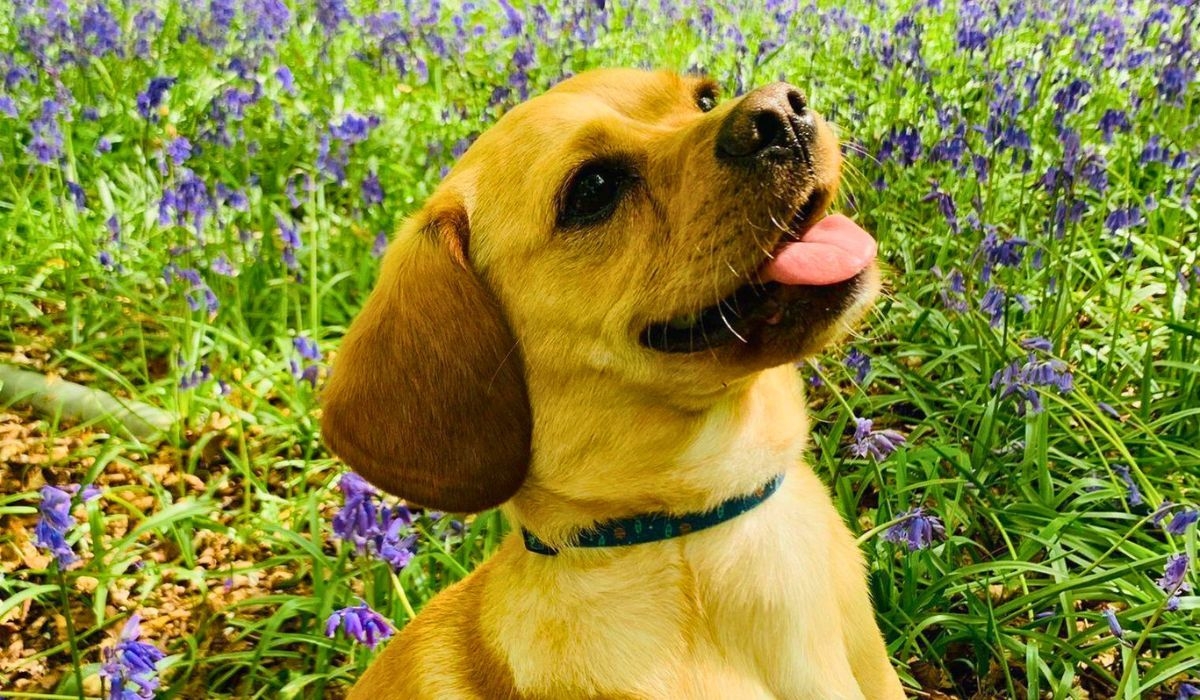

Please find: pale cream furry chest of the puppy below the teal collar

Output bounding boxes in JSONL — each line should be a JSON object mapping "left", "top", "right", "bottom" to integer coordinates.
{"left": 489, "top": 474, "right": 860, "bottom": 698}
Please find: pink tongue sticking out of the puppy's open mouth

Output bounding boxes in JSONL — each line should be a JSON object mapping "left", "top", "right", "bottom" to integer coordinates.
{"left": 762, "top": 214, "right": 875, "bottom": 285}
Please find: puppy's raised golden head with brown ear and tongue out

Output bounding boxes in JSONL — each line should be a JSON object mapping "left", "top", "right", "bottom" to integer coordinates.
{"left": 323, "top": 70, "right": 878, "bottom": 510}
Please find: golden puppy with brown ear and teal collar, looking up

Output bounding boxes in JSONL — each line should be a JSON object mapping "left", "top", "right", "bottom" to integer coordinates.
{"left": 323, "top": 70, "right": 904, "bottom": 700}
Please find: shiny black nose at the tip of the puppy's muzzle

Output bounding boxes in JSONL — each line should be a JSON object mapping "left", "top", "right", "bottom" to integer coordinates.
{"left": 716, "top": 83, "right": 815, "bottom": 164}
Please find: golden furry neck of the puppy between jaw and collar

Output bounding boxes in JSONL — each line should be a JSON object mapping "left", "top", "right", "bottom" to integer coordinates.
{"left": 505, "top": 366, "right": 808, "bottom": 546}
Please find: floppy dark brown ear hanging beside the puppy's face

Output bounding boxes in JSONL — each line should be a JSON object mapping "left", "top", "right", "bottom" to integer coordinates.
{"left": 322, "top": 201, "right": 533, "bottom": 511}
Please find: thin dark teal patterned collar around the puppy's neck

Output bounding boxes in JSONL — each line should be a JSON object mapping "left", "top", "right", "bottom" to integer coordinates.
{"left": 521, "top": 474, "right": 784, "bottom": 557}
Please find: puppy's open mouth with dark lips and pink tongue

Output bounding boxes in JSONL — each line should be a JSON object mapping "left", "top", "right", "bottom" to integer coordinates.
{"left": 640, "top": 191, "right": 876, "bottom": 353}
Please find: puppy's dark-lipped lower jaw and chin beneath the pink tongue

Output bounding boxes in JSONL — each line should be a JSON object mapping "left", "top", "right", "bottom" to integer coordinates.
{"left": 638, "top": 263, "right": 880, "bottom": 369}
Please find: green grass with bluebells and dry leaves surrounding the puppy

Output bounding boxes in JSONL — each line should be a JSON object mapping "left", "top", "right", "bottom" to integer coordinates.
{"left": 0, "top": 0, "right": 1200, "bottom": 699}
